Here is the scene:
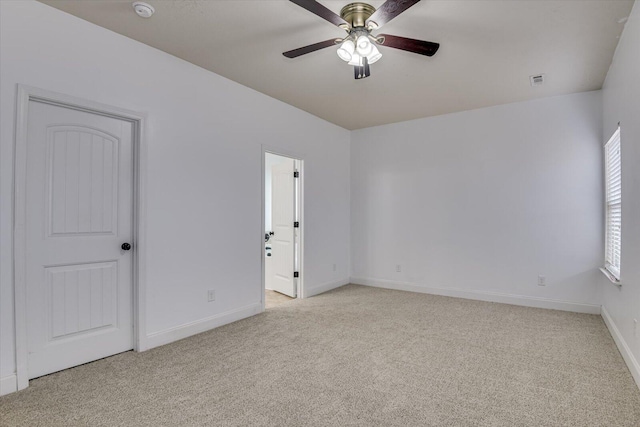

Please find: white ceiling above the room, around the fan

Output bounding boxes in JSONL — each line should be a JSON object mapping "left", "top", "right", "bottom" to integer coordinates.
{"left": 41, "top": 0, "right": 633, "bottom": 129}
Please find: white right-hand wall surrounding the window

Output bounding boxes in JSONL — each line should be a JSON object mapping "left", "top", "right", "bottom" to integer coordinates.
{"left": 602, "top": 2, "right": 640, "bottom": 386}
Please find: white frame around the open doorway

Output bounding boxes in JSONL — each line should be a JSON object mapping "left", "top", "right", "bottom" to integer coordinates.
{"left": 260, "top": 145, "right": 306, "bottom": 311}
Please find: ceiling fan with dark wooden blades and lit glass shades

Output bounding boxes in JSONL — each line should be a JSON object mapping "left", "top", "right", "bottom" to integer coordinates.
{"left": 283, "top": 0, "right": 440, "bottom": 79}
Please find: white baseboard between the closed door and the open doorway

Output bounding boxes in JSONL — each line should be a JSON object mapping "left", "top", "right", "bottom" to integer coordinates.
{"left": 146, "top": 303, "right": 262, "bottom": 350}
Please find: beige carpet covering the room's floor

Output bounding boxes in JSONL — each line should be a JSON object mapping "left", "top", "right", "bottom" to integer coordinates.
{"left": 0, "top": 285, "right": 640, "bottom": 427}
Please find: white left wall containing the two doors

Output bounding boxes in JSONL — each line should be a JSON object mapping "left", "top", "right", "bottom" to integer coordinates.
{"left": 0, "top": 0, "right": 350, "bottom": 392}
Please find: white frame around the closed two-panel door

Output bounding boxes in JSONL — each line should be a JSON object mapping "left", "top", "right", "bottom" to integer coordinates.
{"left": 13, "top": 84, "right": 147, "bottom": 390}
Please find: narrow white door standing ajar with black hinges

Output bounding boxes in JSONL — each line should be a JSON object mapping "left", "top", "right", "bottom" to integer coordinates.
{"left": 271, "top": 159, "right": 296, "bottom": 297}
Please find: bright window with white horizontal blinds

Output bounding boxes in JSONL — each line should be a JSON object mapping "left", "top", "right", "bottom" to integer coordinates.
{"left": 604, "top": 128, "right": 622, "bottom": 280}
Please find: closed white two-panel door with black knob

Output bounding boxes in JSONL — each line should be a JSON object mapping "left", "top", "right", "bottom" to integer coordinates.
{"left": 25, "top": 101, "right": 133, "bottom": 378}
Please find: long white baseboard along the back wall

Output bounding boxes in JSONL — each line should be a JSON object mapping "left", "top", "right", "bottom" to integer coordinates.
{"left": 351, "top": 277, "right": 600, "bottom": 314}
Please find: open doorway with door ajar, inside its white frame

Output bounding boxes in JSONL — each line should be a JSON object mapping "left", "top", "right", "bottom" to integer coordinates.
{"left": 263, "top": 152, "right": 302, "bottom": 309}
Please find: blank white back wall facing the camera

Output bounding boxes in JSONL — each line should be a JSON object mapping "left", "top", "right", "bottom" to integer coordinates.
{"left": 351, "top": 91, "right": 603, "bottom": 313}
